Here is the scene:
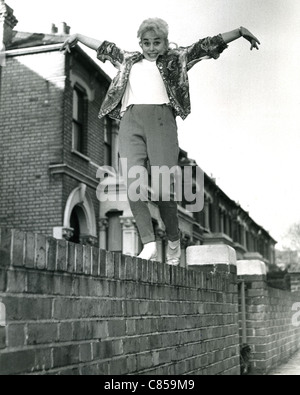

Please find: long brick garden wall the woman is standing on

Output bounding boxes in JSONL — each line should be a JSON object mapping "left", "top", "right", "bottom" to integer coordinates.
{"left": 0, "top": 229, "right": 240, "bottom": 375}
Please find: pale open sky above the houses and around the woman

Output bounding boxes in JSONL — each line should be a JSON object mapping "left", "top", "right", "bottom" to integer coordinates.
{"left": 7, "top": 0, "right": 300, "bottom": 247}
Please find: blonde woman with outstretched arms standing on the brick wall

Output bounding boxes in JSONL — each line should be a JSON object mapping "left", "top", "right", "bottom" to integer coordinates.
{"left": 61, "top": 18, "right": 260, "bottom": 265}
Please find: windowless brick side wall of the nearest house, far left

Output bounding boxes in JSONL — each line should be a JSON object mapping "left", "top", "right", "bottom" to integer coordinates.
{"left": 0, "top": 52, "right": 64, "bottom": 234}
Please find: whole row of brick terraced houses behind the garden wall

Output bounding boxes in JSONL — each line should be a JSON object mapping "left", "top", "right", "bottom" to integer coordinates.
{"left": 0, "top": 0, "right": 276, "bottom": 266}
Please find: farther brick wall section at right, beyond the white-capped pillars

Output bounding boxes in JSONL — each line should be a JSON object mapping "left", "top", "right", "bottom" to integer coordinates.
{"left": 239, "top": 275, "right": 300, "bottom": 373}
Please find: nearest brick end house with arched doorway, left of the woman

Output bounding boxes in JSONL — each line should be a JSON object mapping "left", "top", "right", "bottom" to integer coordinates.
{"left": 0, "top": 6, "right": 113, "bottom": 248}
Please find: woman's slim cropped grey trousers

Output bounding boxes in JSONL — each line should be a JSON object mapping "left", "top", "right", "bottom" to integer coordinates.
{"left": 119, "top": 104, "right": 180, "bottom": 244}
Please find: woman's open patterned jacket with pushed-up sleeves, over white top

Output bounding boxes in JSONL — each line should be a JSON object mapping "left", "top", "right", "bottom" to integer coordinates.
{"left": 97, "top": 35, "right": 227, "bottom": 119}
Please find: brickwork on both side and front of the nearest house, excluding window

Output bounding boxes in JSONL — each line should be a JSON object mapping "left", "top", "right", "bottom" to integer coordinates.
{"left": 0, "top": 51, "right": 108, "bottom": 240}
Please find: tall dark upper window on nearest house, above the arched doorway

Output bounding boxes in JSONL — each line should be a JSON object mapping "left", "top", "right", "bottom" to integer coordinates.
{"left": 73, "top": 85, "right": 87, "bottom": 155}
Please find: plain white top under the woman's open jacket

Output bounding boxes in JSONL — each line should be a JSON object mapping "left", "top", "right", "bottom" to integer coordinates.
{"left": 121, "top": 59, "right": 170, "bottom": 114}
